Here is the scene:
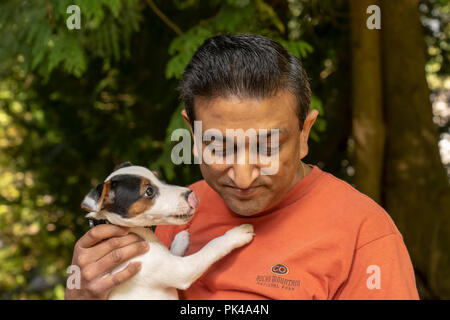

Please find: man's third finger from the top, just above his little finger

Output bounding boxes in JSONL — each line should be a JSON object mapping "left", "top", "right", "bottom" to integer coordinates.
{"left": 82, "top": 241, "right": 149, "bottom": 281}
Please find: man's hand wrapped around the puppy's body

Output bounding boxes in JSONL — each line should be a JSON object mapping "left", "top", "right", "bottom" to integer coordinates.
{"left": 65, "top": 224, "right": 149, "bottom": 300}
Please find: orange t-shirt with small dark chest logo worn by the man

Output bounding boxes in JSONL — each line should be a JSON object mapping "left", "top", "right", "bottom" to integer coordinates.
{"left": 156, "top": 166, "right": 419, "bottom": 300}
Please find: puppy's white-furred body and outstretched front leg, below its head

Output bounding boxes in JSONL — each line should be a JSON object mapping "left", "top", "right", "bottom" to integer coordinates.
{"left": 108, "top": 224, "right": 254, "bottom": 300}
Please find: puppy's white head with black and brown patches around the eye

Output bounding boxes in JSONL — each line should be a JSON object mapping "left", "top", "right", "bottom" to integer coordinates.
{"left": 81, "top": 163, "right": 198, "bottom": 227}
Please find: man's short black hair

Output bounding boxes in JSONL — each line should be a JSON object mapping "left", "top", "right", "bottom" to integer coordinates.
{"left": 179, "top": 34, "right": 311, "bottom": 129}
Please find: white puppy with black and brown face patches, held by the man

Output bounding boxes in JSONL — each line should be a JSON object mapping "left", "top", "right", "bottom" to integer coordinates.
{"left": 81, "top": 162, "right": 254, "bottom": 300}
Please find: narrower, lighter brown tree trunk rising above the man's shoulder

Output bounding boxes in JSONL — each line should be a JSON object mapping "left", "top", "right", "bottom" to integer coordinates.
{"left": 350, "top": 0, "right": 385, "bottom": 203}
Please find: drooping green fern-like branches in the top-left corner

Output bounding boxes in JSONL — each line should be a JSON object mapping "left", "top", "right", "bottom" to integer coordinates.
{"left": 0, "top": 0, "right": 141, "bottom": 79}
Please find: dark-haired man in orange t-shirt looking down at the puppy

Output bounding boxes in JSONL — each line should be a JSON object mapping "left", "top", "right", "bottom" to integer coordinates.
{"left": 66, "top": 35, "right": 418, "bottom": 299}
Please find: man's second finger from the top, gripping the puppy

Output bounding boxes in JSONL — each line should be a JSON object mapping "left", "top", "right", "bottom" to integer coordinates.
{"left": 78, "top": 233, "right": 143, "bottom": 266}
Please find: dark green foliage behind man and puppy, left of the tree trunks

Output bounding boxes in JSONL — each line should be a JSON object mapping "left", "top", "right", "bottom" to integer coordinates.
{"left": 0, "top": 0, "right": 442, "bottom": 299}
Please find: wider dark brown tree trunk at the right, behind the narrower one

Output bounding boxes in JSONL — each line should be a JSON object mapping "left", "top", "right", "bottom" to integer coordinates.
{"left": 381, "top": 0, "right": 450, "bottom": 299}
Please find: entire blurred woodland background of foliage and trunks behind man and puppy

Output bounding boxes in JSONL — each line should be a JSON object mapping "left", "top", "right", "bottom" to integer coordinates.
{"left": 0, "top": 0, "right": 450, "bottom": 299}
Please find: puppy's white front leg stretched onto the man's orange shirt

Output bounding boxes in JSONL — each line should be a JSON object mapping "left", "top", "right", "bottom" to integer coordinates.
{"left": 174, "top": 224, "right": 255, "bottom": 290}
